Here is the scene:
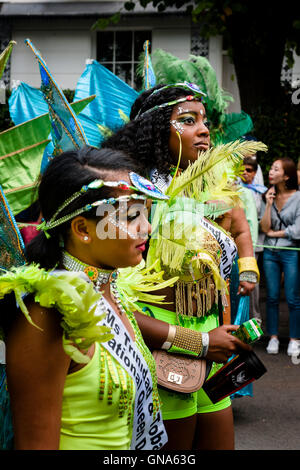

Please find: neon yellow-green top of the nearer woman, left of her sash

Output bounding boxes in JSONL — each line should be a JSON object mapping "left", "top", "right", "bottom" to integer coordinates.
{"left": 60, "top": 343, "right": 135, "bottom": 450}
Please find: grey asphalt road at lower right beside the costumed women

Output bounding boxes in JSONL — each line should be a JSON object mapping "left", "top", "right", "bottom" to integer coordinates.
{"left": 232, "top": 282, "right": 300, "bottom": 450}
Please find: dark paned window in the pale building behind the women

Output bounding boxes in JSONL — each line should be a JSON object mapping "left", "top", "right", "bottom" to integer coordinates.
{"left": 97, "top": 31, "right": 151, "bottom": 90}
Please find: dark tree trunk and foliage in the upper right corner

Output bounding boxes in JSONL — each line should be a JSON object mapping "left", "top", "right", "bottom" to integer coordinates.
{"left": 125, "top": 0, "right": 300, "bottom": 175}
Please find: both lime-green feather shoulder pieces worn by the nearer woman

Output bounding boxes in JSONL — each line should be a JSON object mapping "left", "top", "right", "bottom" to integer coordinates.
{"left": 0, "top": 261, "right": 178, "bottom": 363}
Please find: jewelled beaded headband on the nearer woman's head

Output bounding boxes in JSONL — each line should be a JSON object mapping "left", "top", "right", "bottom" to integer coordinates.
{"left": 37, "top": 172, "right": 169, "bottom": 238}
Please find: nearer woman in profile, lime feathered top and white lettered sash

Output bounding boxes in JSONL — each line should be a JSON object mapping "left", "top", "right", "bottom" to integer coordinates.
{"left": 0, "top": 147, "right": 248, "bottom": 450}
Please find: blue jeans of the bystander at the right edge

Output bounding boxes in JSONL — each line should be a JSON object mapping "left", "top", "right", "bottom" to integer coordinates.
{"left": 263, "top": 248, "right": 300, "bottom": 338}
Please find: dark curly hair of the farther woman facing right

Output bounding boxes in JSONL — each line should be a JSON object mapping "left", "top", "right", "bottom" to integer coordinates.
{"left": 102, "top": 85, "right": 199, "bottom": 182}
